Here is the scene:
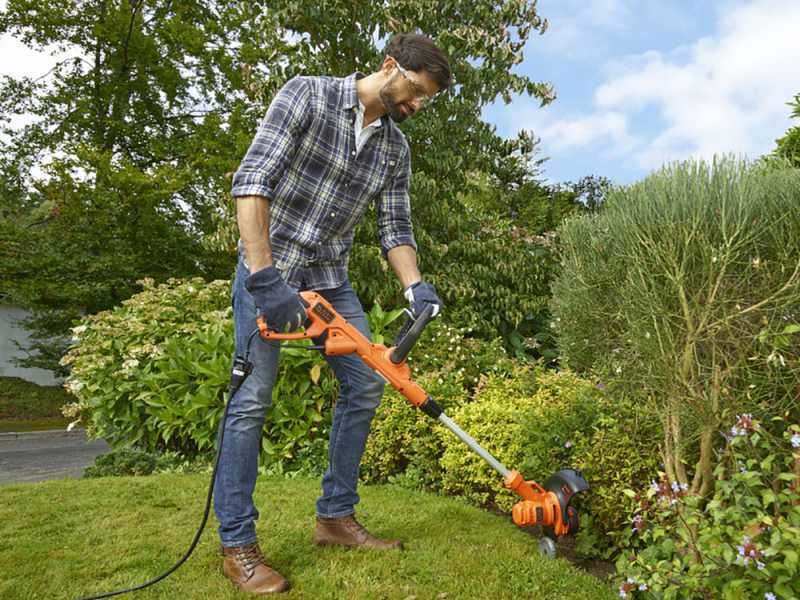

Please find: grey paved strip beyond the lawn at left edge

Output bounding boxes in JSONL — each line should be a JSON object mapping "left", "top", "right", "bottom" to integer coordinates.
{"left": 0, "top": 429, "right": 109, "bottom": 485}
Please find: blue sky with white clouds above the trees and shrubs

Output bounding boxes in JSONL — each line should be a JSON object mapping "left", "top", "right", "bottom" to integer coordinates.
{"left": 0, "top": 0, "right": 800, "bottom": 184}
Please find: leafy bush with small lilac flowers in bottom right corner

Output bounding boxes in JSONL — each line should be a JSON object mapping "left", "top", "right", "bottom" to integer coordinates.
{"left": 617, "top": 414, "right": 800, "bottom": 600}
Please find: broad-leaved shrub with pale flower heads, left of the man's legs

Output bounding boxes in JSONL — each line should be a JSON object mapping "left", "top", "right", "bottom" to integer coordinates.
{"left": 62, "top": 279, "right": 233, "bottom": 453}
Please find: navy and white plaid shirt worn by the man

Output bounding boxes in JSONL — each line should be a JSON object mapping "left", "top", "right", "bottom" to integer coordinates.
{"left": 231, "top": 73, "right": 417, "bottom": 289}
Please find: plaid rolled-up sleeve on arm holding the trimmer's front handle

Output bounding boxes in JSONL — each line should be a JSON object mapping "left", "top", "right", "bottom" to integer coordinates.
{"left": 378, "top": 146, "right": 417, "bottom": 258}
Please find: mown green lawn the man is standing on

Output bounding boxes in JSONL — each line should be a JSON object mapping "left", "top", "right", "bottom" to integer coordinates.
{"left": 0, "top": 474, "right": 616, "bottom": 600}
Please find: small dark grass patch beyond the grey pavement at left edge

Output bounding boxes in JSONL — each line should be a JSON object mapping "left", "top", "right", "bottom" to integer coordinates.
{"left": 0, "top": 377, "right": 72, "bottom": 433}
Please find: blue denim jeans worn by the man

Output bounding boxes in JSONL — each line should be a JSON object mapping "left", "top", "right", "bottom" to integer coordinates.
{"left": 214, "top": 255, "right": 384, "bottom": 546}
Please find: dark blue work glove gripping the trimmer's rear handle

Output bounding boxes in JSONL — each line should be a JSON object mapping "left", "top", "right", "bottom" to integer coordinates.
{"left": 244, "top": 266, "right": 306, "bottom": 333}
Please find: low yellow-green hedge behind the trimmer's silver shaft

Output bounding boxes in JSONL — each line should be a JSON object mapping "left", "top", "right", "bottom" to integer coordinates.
{"left": 362, "top": 362, "right": 661, "bottom": 557}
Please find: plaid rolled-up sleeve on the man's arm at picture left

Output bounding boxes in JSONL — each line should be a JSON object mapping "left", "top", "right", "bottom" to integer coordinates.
{"left": 231, "top": 77, "right": 311, "bottom": 199}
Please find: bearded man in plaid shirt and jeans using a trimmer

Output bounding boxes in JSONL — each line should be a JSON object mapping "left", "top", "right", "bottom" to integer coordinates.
{"left": 214, "top": 34, "right": 451, "bottom": 593}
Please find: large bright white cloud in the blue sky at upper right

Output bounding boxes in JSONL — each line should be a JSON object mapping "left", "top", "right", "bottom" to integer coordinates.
{"left": 580, "top": 0, "right": 800, "bottom": 169}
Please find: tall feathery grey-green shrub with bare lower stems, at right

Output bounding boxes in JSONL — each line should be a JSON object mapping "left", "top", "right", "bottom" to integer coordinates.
{"left": 551, "top": 159, "right": 800, "bottom": 495}
